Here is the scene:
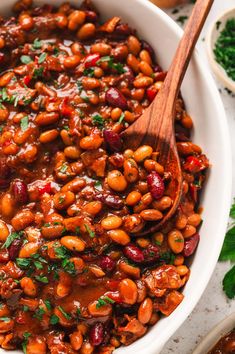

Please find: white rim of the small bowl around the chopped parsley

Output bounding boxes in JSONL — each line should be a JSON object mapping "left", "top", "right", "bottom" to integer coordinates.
{"left": 206, "top": 8, "right": 235, "bottom": 92}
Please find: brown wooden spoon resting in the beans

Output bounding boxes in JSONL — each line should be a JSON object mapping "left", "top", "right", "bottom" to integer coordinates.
{"left": 122, "top": 0, "right": 214, "bottom": 235}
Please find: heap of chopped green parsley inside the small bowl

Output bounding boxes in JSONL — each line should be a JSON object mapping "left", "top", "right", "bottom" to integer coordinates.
{"left": 214, "top": 18, "right": 235, "bottom": 81}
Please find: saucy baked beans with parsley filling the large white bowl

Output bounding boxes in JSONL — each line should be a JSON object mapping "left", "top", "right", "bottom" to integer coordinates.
{"left": 0, "top": 0, "right": 209, "bottom": 354}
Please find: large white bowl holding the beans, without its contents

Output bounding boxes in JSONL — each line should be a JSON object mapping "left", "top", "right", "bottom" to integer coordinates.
{"left": 0, "top": 0, "right": 232, "bottom": 354}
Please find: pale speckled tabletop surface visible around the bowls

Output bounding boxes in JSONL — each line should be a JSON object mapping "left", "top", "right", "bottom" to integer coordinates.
{"left": 162, "top": 0, "right": 235, "bottom": 354}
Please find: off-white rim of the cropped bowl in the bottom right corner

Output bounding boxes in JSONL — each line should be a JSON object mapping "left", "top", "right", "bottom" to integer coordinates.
{"left": 192, "top": 312, "right": 235, "bottom": 354}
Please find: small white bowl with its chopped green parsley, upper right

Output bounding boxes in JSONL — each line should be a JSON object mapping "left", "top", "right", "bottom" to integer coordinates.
{"left": 206, "top": 8, "right": 235, "bottom": 92}
